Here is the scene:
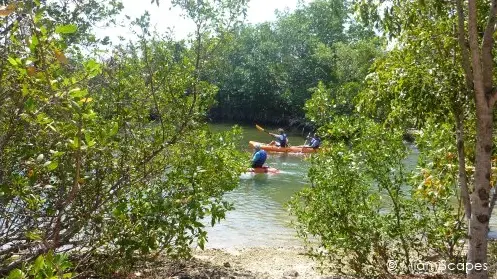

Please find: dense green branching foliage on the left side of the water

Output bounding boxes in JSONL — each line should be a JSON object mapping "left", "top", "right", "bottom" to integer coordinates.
{"left": 0, "top": 1, "right": 246, "bottom": 278}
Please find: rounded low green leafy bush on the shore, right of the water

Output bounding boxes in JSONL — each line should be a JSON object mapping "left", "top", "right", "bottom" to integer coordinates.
{"left": 290, "top": 118, "right": 464, "bottom": 277}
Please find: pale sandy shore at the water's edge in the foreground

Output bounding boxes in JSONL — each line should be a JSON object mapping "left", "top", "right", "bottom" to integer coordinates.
{"left": 134, "top": 247, "right": 464, "bottom": 279}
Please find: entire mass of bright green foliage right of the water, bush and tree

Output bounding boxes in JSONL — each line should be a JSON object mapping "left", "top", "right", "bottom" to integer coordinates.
{"left": 291, "top": 0, "right": 497, "bottom": 278}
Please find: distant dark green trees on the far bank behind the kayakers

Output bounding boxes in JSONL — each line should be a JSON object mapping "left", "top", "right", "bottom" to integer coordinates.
{"left": 205, "top": 0, "right": 381, "bottom": 127}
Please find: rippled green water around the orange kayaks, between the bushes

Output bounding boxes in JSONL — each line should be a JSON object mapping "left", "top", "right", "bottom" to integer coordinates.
{"left": 206, "top": 124, "right": 309, "bottom": 248}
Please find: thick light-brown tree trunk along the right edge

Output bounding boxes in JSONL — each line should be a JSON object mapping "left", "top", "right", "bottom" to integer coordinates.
{"left": 459, "top": 0, "right": 497, "bottom": 279}
